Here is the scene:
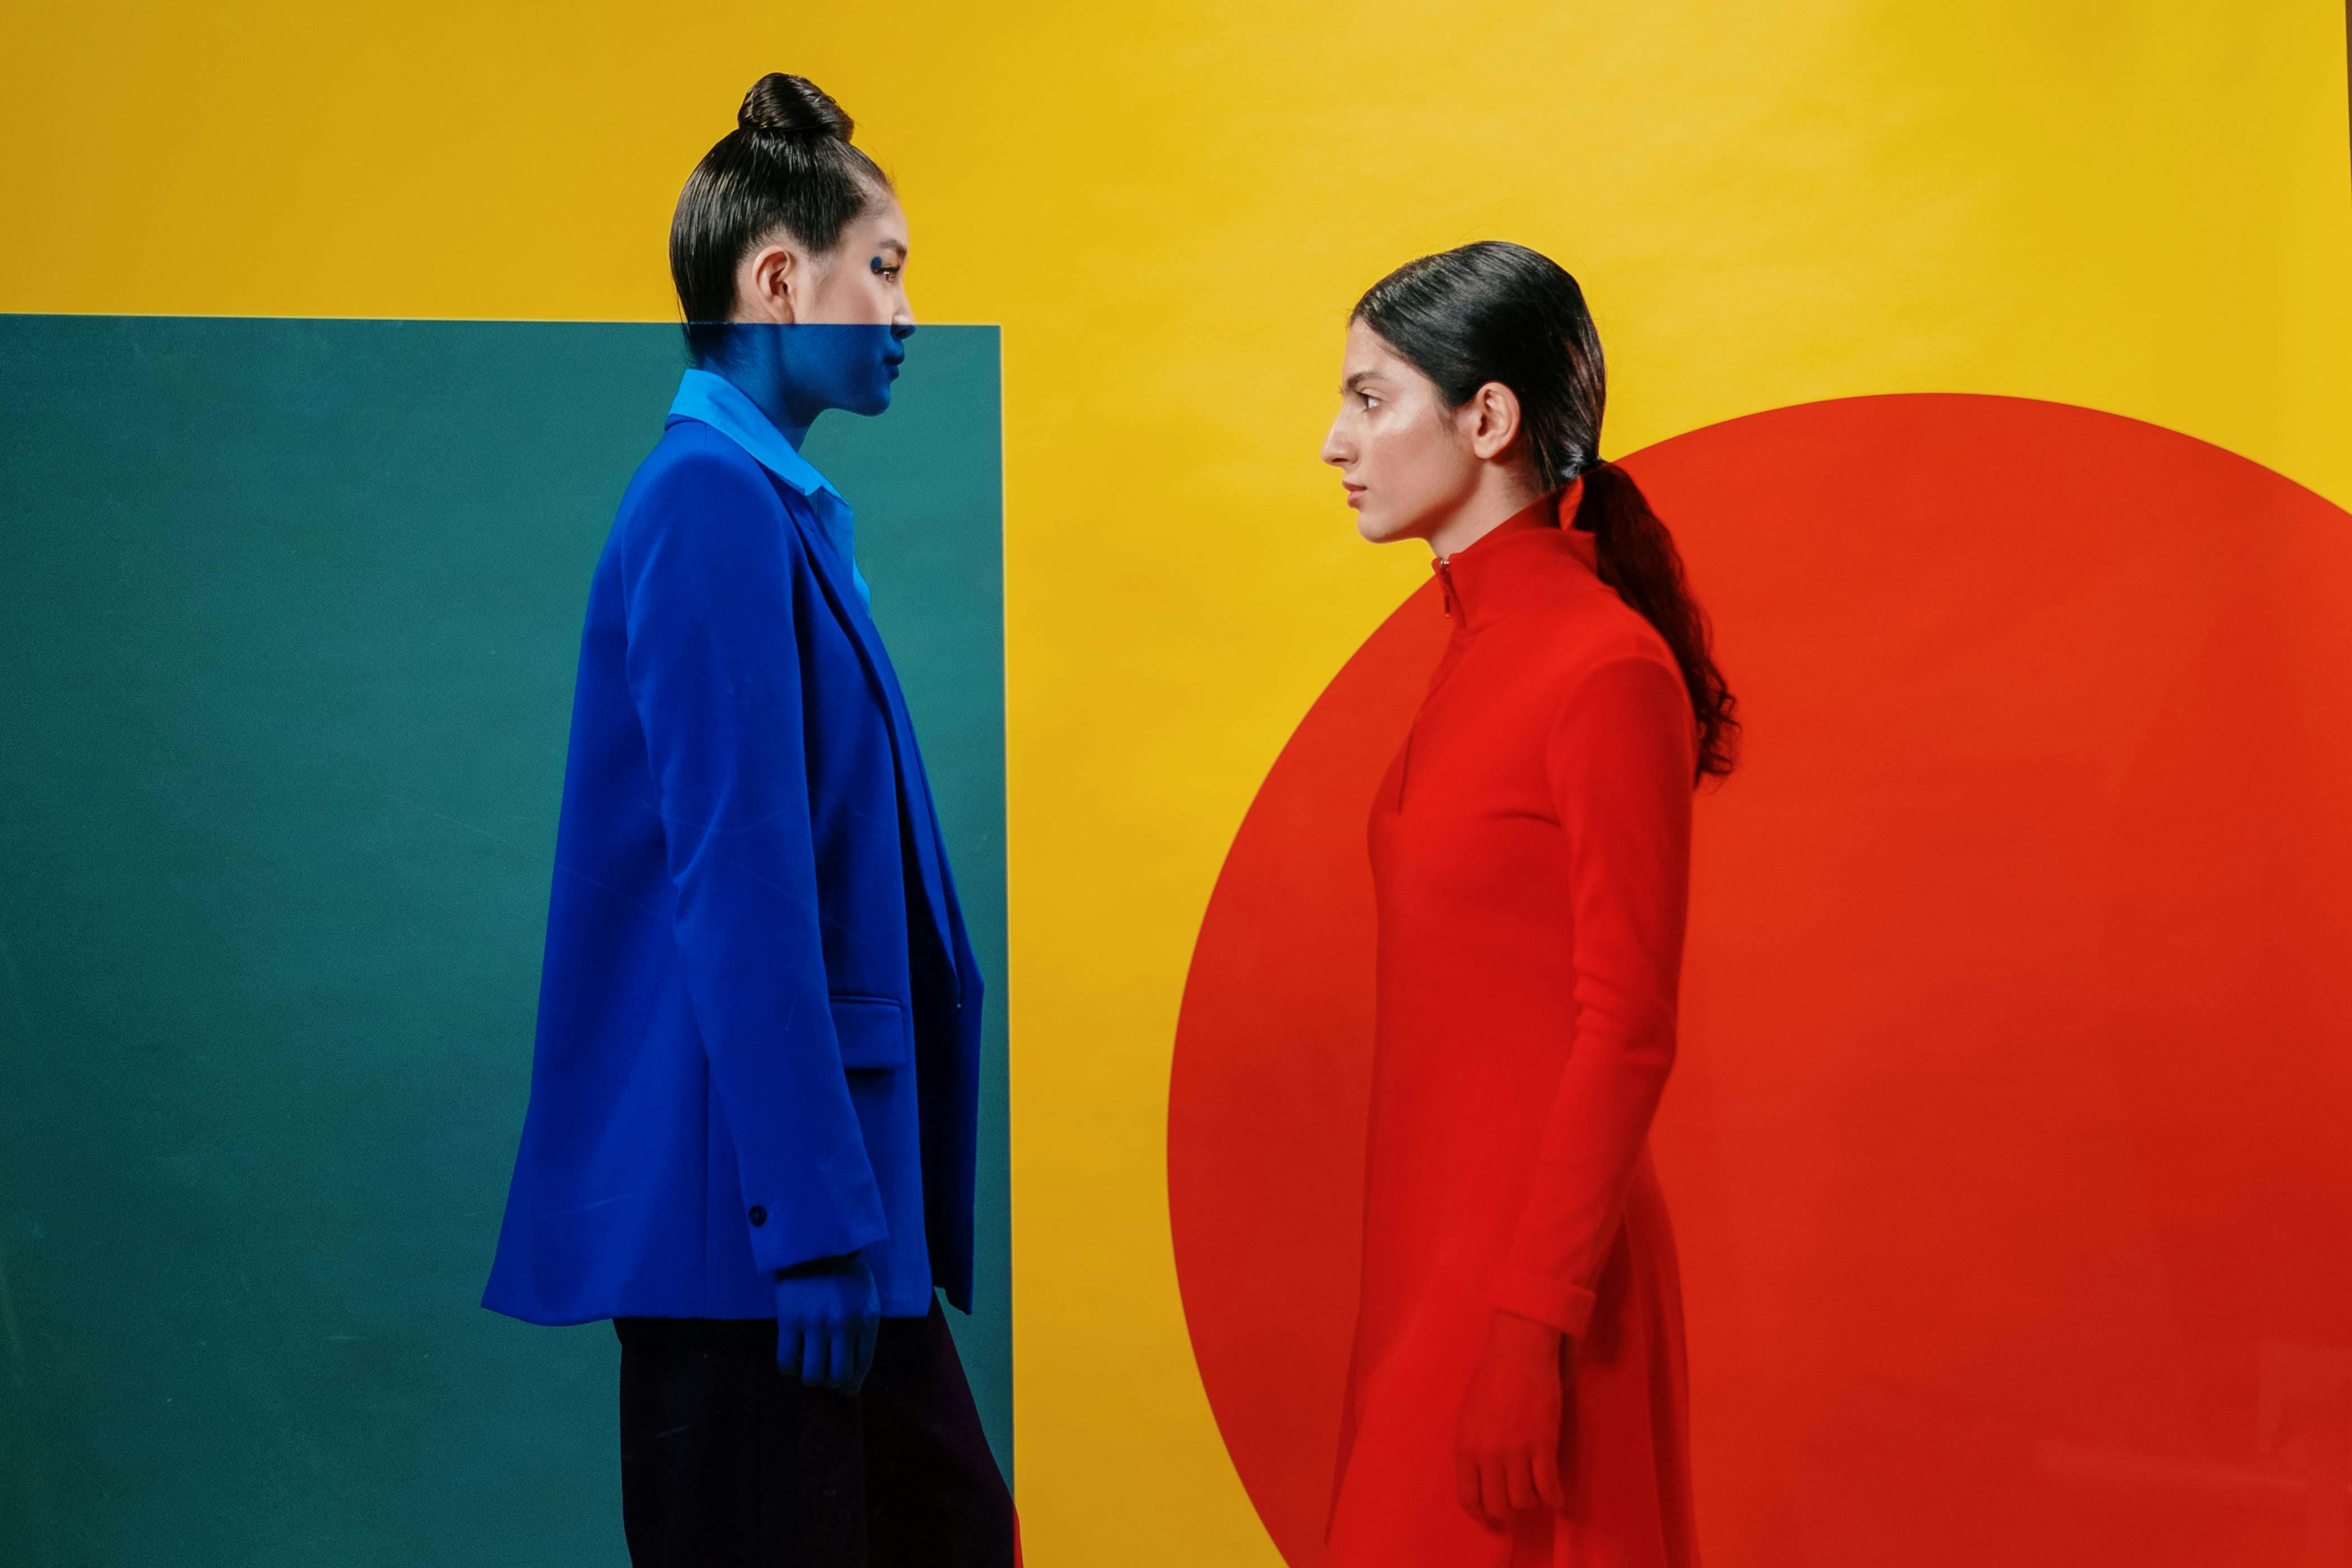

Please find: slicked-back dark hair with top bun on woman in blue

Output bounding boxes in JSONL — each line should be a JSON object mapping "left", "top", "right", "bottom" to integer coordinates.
{"left": 670, "top": 71, "right": 892, "bottom": 364}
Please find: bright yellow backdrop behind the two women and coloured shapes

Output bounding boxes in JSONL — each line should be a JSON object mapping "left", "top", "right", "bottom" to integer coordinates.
{"left": 0, "top": 0, "right": 2352, "bottom": 1568}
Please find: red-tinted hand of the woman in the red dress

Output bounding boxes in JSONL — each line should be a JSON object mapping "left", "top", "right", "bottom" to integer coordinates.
{"left": 1454, "top": 1312, "right": 1569, "bottom": 1530}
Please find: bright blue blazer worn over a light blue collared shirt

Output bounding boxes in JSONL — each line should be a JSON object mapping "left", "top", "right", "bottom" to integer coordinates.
{"left": 482, "top": 397, "right": 981, "bottom": 1324}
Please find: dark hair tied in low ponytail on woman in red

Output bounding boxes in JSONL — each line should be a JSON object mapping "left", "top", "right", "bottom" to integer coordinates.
{"left": 1352, "top": 240, "right": 1741, "bottom": 778}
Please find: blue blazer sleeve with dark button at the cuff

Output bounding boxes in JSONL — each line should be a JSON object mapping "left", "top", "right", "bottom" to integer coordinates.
{"left": 621, "top": 461, "right": 889, "bottom": 1269}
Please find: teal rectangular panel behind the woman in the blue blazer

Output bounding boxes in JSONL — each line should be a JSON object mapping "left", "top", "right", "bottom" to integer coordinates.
{"left": 0, "top": 317, "right": 1012, "bottom": 1568}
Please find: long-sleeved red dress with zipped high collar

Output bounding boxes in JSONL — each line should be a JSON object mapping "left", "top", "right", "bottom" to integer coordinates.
{"left": 1326, "top": 484, "right": 1698, "bottom": 1568}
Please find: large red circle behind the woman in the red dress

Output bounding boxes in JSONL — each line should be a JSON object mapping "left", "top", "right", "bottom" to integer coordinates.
{"left": 1169, "top": 395, "right": 2352, "bottom": 1568}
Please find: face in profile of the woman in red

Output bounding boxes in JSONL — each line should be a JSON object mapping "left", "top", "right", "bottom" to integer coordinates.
{"left": 1322, "top": 322, "right": 1479, "bottom": 545}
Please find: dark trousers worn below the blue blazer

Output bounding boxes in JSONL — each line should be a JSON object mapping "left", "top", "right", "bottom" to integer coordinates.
{"left": 614, "top": 1300, "right": 1014, "bottom": 1568}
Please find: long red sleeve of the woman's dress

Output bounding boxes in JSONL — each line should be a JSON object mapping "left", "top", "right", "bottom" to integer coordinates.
{"left": 1493, "top": 656, "right": 1698, "bottom": 1333}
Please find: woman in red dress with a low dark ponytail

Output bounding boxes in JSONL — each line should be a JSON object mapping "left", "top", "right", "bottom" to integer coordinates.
{"left": 1322, "top": 244, "right": 1736, "bottom": 1568}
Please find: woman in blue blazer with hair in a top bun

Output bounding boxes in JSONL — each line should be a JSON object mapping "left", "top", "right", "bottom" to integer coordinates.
{"left": 482, "top": 75, "right": 1014, "bottom": 1566}
